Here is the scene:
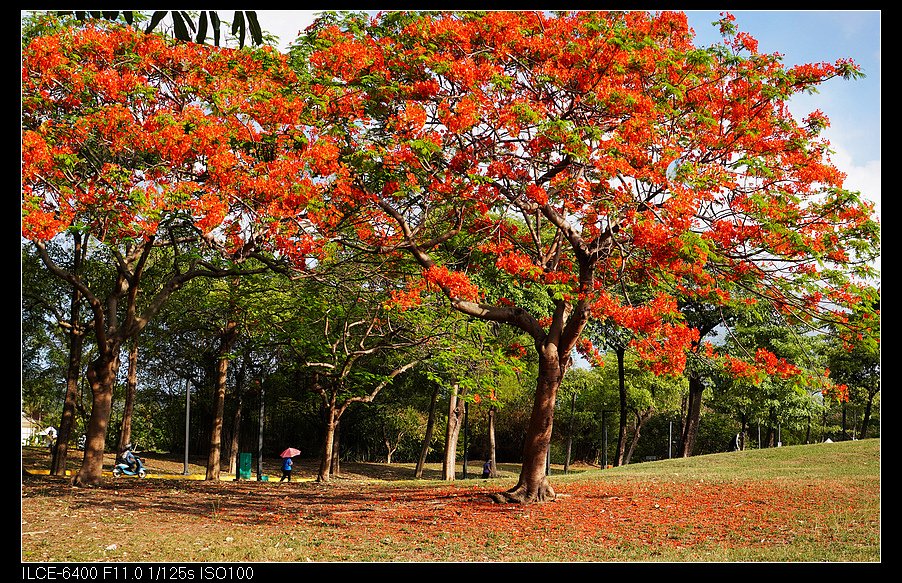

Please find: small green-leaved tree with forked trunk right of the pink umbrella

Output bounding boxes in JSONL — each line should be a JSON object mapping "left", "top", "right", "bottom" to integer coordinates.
{"left": 260, "top": 263, "right": 445, "bottom": 482}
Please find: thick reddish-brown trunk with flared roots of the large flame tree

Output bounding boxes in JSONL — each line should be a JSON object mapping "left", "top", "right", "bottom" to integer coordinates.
{"left": 491, "top": 345, "right": 569, "bottom": 504}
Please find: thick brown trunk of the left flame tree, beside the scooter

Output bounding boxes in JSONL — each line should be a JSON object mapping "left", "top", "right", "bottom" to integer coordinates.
{"left": 72, "top": 354, "right": 119, "bottom": 486}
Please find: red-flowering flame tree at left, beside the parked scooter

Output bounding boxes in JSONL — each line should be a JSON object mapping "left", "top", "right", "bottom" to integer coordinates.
{"left": 21, "top": 22, "right": 318, "bottom": 485}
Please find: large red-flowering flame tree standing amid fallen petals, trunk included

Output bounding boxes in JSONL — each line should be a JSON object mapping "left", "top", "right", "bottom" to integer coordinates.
{"left": 282, "top": 11, "right": 878, "bottom": 503}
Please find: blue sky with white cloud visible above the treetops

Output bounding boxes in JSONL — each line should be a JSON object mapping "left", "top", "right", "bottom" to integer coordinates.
{"left": 257, "top": 10, "right": 881, "bottom": 221}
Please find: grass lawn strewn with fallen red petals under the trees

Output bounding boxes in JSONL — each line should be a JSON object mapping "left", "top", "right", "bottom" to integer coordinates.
{"left": 21, "top": 439, "right": 881, "bottom": 568}
